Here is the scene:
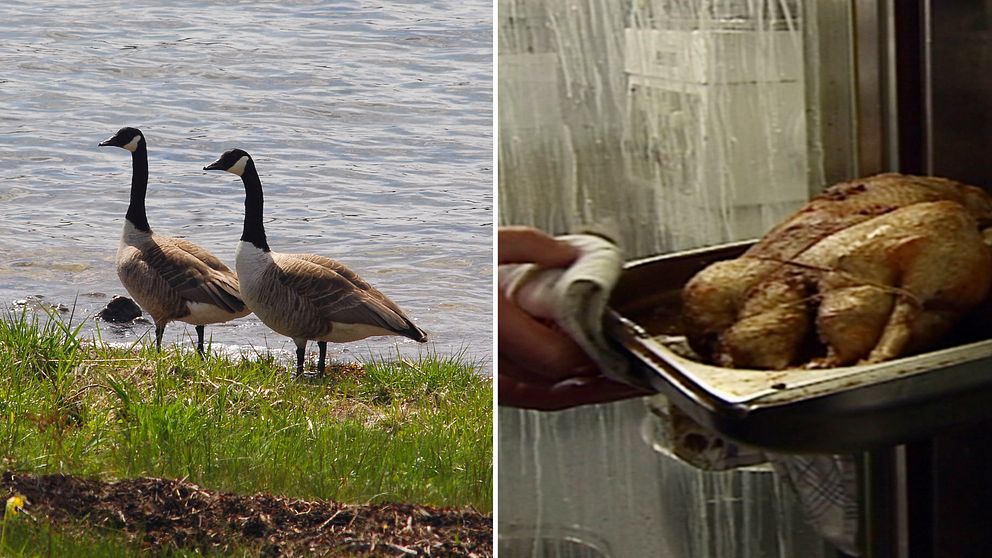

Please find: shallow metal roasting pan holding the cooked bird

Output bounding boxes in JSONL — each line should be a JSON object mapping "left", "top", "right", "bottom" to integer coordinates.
{"left": 605, "top": 242, "right": 992, "bottom": 453}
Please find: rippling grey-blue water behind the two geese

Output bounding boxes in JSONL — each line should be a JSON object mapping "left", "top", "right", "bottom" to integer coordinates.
{"left": 0, "top": 0, "right": 493, "bottom": 368}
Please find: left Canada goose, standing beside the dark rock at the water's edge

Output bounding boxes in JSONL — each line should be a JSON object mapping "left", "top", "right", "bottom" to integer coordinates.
{"left": 100, "top": 127, "right": 251, "bottom": 356}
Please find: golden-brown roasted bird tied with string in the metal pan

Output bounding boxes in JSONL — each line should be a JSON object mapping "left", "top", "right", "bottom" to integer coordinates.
{"left": 683, "top": 174, "right": 992, "bottom": 369}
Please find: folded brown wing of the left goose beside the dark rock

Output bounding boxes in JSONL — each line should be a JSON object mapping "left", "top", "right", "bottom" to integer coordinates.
{"left": 145, "top": 235, "right": 245, "bottom": 313}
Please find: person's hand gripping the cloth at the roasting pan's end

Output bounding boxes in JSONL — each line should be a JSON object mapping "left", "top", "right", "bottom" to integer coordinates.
{"left": 497, "top": 227, "right": 647, "bottom": 410}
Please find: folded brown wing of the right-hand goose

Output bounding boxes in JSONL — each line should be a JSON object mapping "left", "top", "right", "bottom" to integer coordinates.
{"left": 277, "top": 254, "right": 426, "bottom": 341}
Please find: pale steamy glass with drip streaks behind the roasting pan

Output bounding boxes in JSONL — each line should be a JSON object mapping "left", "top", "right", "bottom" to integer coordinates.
{"left": 498, "top": 0, "right": 840, "bottom": 558}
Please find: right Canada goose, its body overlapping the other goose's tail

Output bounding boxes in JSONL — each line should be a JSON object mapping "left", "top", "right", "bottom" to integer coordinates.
{"left": 203, "top": 149, "right": 427, "bottom": 375}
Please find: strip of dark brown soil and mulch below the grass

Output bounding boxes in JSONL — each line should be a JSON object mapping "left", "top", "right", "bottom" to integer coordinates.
{"left": 0, "top": 472, "right": 493, "bottom": 558}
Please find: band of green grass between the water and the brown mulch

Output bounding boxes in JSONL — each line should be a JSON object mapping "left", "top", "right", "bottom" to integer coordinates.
{"left": 0, "top": 313, "right": 492, "bottom": 511}
